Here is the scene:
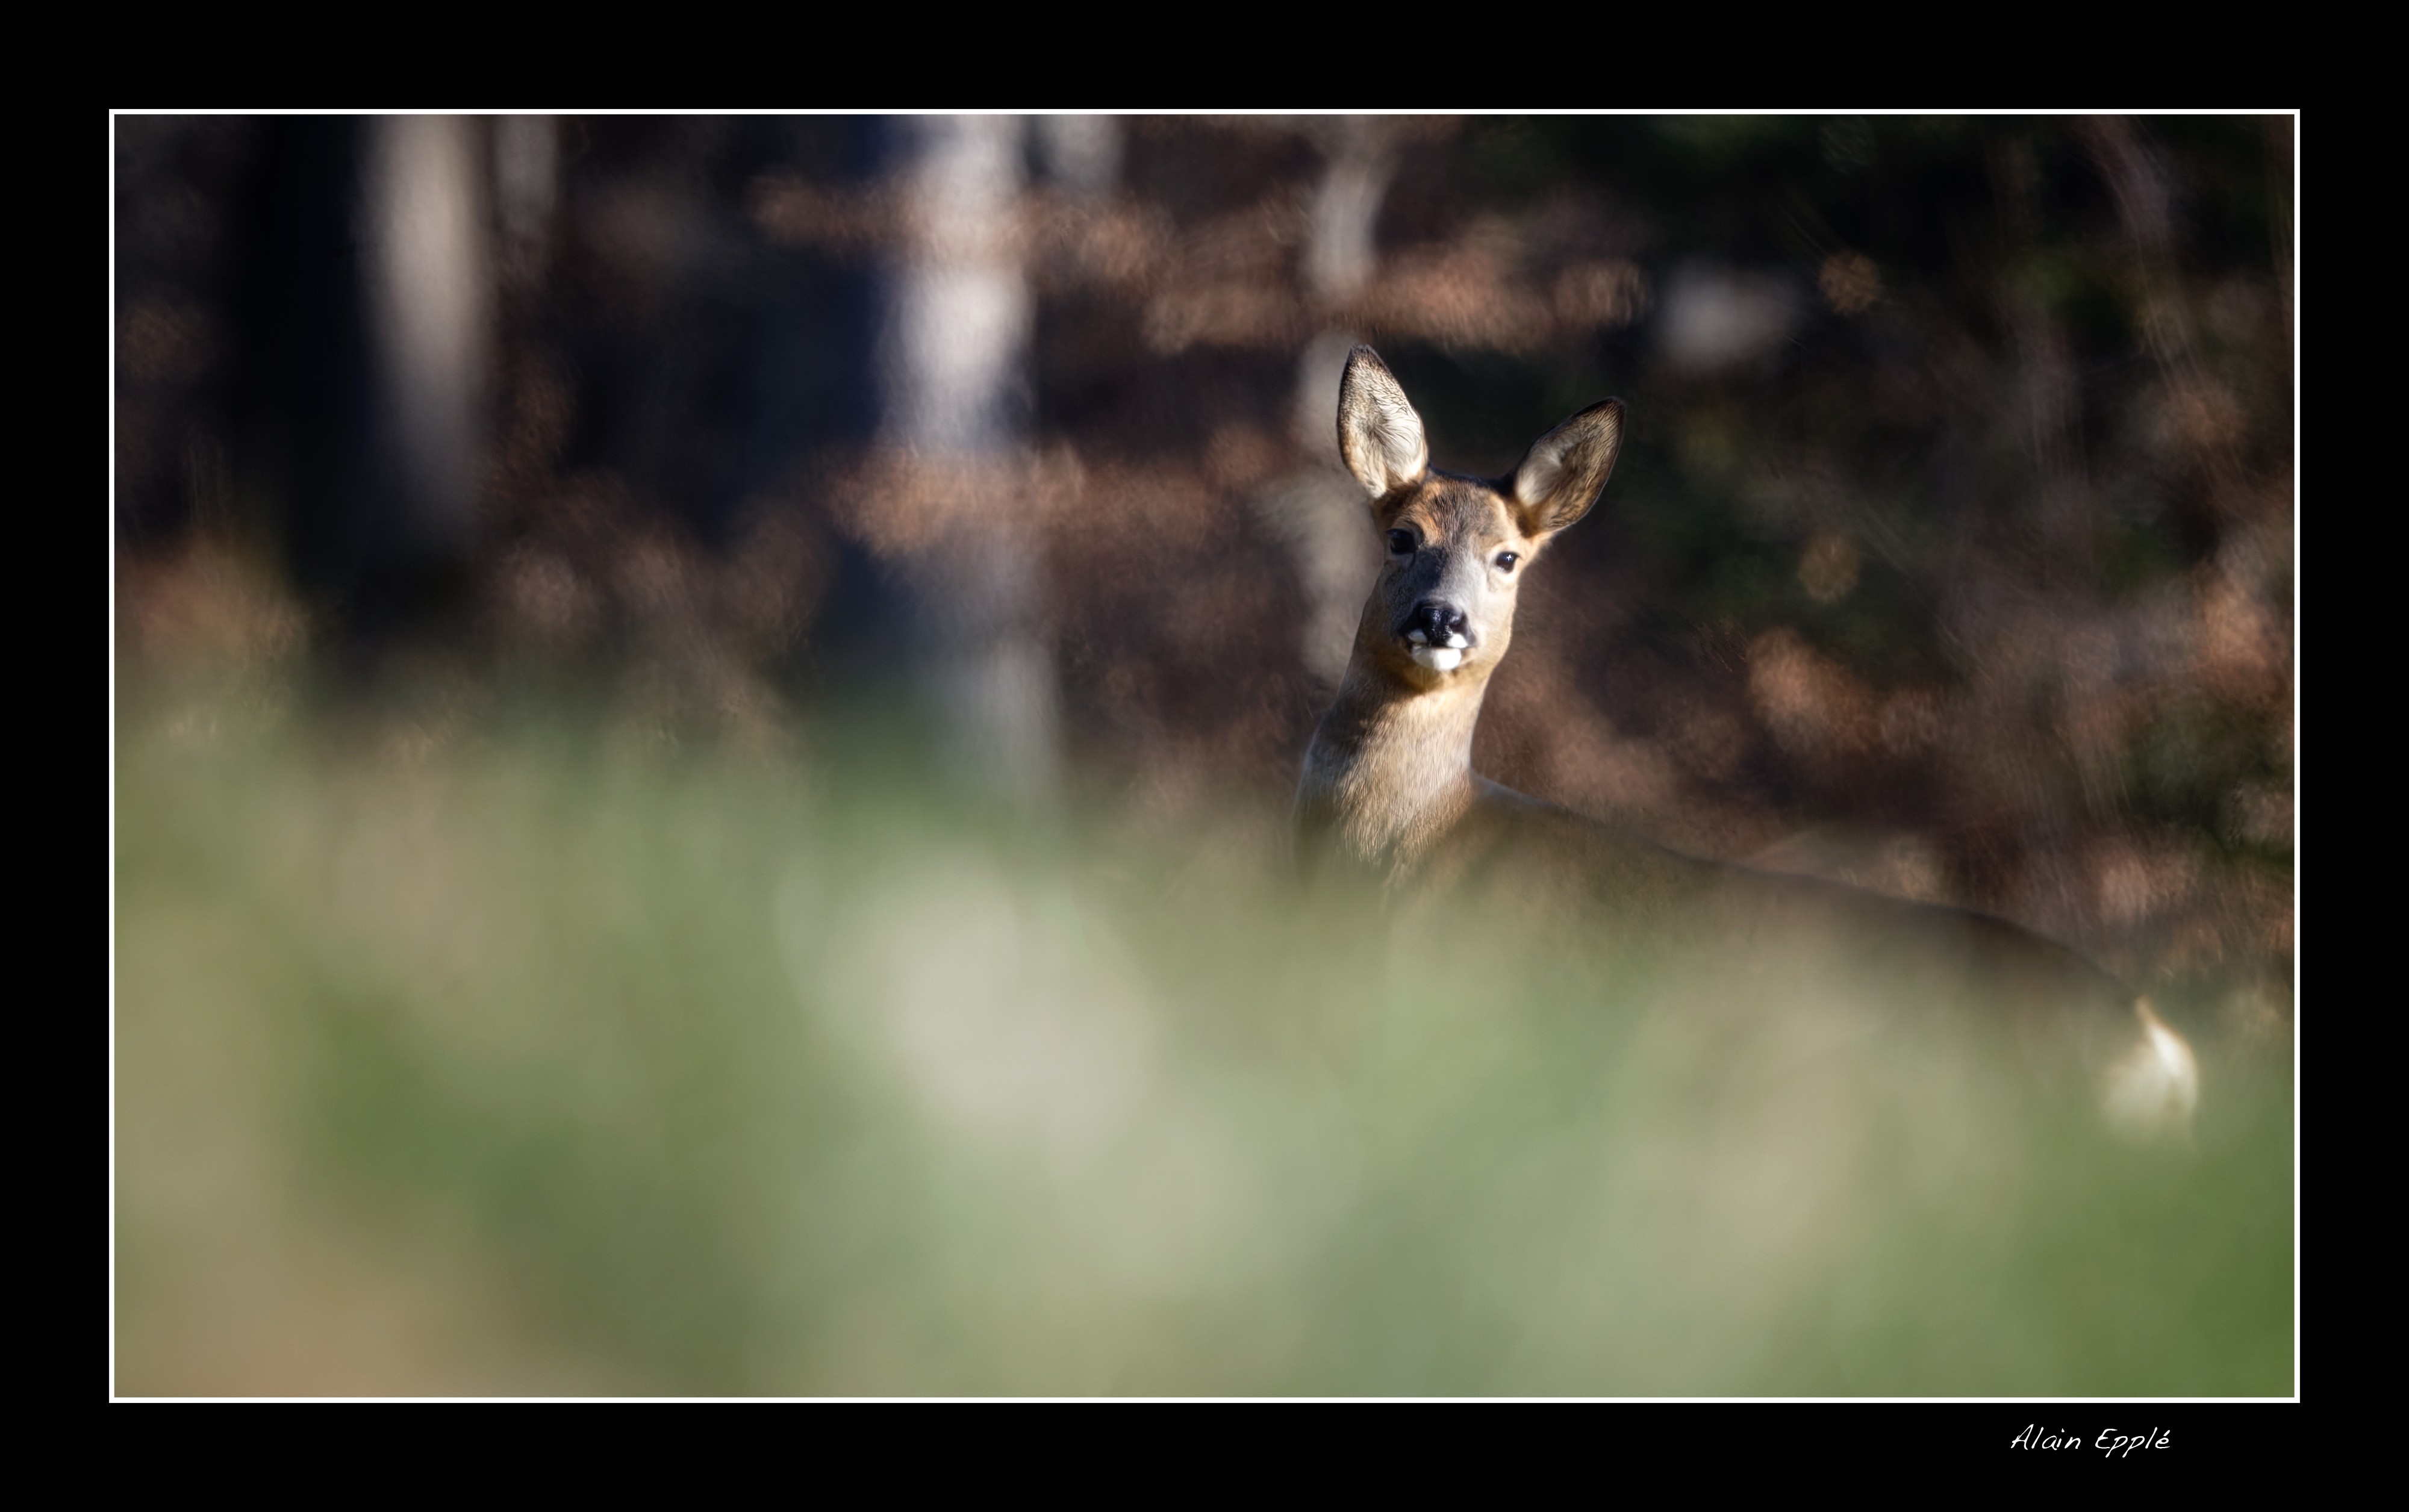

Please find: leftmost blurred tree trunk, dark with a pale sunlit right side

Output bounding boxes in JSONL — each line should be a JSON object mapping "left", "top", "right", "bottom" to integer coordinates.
{"left": 238, "top": 116, "right": 491, "bottom": 636}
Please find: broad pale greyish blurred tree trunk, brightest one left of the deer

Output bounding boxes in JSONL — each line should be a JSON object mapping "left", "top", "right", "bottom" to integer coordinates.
{"left": 879, "top": 116, "right": 1058, "bottom": 797}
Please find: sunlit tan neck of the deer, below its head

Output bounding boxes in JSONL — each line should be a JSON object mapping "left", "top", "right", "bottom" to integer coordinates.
{"left": 1296, "top": 653, "right": 1489, "bottom": 864}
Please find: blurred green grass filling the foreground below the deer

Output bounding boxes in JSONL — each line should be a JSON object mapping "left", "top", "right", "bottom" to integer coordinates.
{"left": 116, "top": 696, "right": 2293, "bottom": 1394}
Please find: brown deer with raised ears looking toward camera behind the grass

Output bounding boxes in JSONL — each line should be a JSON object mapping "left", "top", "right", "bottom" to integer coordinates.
{"left": 1294, "top": 347, "right": 2199, "bottom": 1139}
